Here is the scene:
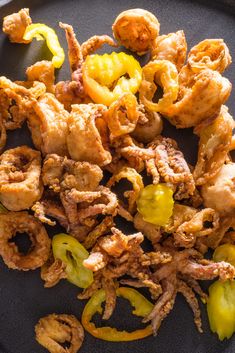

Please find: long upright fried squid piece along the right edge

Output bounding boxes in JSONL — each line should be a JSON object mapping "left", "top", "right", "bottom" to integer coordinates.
{"left": 193, "top": 105, "right": 235, "bottom": 185}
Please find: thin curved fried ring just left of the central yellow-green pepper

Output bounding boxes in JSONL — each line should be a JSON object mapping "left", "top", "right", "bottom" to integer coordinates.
{"left": 107, "top": 167, "right": 144, "bottom": 214}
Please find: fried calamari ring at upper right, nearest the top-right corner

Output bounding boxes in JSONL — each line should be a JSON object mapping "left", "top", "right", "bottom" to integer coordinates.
{"left": 188, "top": 39, "right": 232, "bottom": 73}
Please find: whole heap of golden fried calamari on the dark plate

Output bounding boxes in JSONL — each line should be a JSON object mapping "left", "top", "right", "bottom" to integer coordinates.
{"left": 0, "top": 5, "right": 235, "bottom": 353}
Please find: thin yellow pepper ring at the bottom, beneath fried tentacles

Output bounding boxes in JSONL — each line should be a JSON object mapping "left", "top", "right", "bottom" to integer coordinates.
{"left": 82, "top": 287, "right": 153, "bottom": 342}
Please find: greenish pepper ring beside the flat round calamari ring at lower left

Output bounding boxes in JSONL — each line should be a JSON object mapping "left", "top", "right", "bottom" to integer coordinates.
{"left": 52, "top": 233, "right": 93, "bottom": 288}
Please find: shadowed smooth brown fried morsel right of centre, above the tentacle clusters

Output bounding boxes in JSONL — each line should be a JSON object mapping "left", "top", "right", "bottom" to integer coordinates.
{"left": 131, "top": 106, "right": 163, "bottom": 143}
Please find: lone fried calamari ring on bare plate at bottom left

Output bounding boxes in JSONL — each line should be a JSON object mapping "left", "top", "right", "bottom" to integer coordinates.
{"left": 35, "top": 314, "right": 84, "bottom": 353}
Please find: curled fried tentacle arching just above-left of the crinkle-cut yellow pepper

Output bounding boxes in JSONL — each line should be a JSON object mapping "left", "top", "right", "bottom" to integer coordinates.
{"left": 81, "top": 34, "right": 117, "bottom": 60}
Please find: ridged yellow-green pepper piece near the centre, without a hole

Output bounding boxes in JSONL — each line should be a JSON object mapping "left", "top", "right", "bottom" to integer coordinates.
{"left": 137, "top": 184, "right": 174, "bottom": 226}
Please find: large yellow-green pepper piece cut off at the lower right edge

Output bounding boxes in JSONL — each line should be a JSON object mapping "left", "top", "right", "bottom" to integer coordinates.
{"left": 207, "top": 281, "right": 235, "bottom": 340}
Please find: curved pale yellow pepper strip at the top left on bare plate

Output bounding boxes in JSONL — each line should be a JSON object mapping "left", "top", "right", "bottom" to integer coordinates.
{"left": 23, "top": 23, "right": 65, "bottom": 69}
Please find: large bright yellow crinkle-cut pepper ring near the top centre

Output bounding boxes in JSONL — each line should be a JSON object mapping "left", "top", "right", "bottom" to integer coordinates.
{"left": 82, "top": 53, "right": 142, "bottom": 106}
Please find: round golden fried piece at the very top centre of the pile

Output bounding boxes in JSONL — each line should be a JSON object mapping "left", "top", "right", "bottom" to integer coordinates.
{"left": 112, "top": 9, "right": 160, "bottom": 55}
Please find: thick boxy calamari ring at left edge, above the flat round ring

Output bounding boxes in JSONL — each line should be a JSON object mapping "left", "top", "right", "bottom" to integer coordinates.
{"left": 0, "top": 146, "right": 43, "bottom": 211}
